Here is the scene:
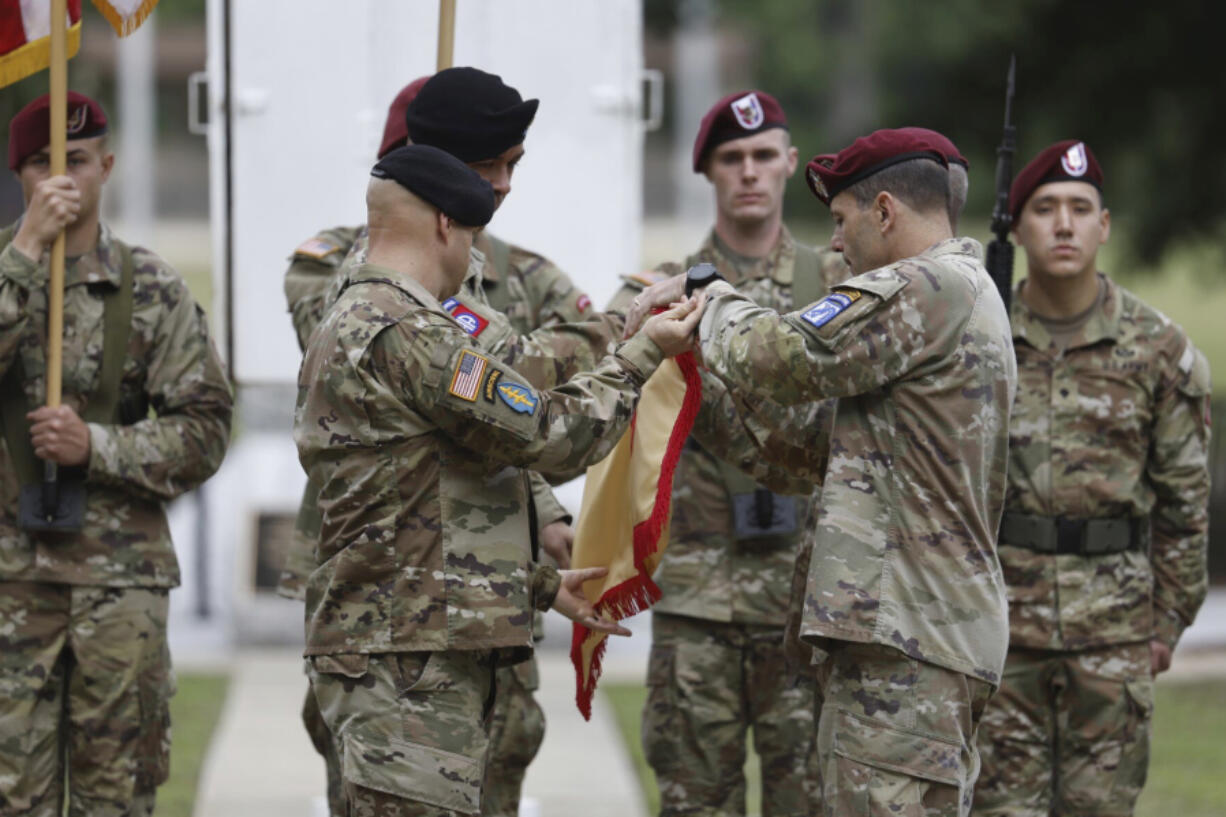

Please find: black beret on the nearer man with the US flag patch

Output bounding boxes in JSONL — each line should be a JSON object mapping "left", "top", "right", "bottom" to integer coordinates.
{"left": 370, "top": 145, "right": 494, "bottom": 227}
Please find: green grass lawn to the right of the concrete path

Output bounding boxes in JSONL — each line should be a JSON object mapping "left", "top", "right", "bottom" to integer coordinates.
{"left": 601, "top": 680, "right": 1226, "bottom": 817}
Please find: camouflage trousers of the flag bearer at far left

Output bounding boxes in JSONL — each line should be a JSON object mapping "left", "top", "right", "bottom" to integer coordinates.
{"left": 0, "top": 581, "right": 174, "bottom": 817}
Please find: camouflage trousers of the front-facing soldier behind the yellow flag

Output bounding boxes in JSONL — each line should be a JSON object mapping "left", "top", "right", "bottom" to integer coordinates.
{"left": 642, "top": 613, "right": 817, "bottom": 817}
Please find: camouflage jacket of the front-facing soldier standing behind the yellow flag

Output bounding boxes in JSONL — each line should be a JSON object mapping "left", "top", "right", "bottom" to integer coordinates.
{"left": 609, "top": 227, "right": 847, "bottom": 627}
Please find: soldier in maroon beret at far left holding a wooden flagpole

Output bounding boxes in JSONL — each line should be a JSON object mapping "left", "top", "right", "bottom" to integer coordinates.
{"left": 0, "top": 92, "right": 233, "bottom": 815}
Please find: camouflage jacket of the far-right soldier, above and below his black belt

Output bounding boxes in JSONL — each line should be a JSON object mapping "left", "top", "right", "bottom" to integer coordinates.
{"left": 1000, "top": 277, "right": 1209, "bottom": 650}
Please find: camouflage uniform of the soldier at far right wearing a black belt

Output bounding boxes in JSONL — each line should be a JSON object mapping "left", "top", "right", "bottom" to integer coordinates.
{"left": 975, "top": 277, "right": 1209, "bottom": 816}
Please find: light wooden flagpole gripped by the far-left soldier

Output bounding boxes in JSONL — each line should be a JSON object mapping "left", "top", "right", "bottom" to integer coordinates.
{"left": 47, "top": 0, "right": 69, "bottom": 409}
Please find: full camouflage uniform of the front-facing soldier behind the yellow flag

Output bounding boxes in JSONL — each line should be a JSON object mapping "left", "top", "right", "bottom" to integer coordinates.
{"left": 609, "top": 227, "right": 847, "bottom": 817}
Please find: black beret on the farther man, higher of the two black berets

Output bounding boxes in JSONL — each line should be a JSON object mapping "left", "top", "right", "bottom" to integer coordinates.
{"left": 405, "top": 67, "right": 539, "bottom": 162}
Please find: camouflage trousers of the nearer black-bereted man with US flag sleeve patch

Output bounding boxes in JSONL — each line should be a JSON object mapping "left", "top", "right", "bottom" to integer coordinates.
{"left": 307, "top": 650, "right": 494, "bottom": 817}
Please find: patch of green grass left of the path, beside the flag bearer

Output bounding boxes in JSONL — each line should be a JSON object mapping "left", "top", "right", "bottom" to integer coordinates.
{"left": 156, "top": 672, "right": 229, "bottom": 817}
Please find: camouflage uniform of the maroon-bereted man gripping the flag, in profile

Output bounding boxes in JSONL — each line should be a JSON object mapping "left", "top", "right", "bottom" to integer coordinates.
{"left": 700, "top": 238, "right": 1016, "bottom": 816}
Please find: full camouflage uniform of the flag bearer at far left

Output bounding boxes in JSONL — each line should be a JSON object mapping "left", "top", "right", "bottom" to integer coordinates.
{"left": 0, "top": 226, "right": 232, "bottom": 817}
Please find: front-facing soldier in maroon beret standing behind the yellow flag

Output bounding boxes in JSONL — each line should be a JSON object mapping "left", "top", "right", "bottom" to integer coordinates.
{"left": 609, "top": 90, "right": 848, "bottom": 815}
